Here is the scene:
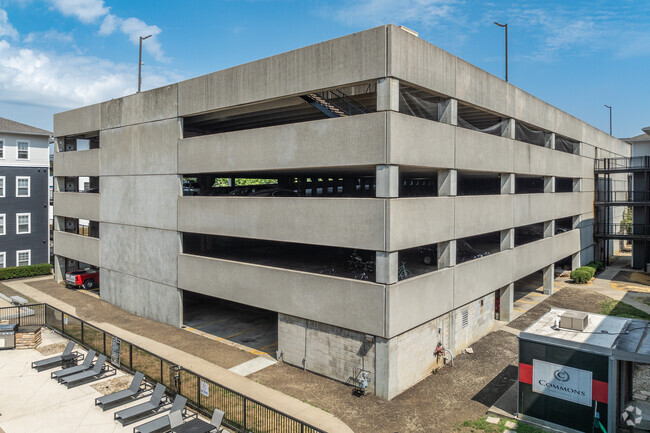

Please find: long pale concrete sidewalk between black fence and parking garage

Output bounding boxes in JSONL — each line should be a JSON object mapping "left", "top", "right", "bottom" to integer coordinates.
{"left": 3, "top": 277, "right": 352, "bottom": 433}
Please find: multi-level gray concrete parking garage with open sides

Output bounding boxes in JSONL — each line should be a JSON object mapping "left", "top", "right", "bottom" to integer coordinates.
{"left": 54, "top": 25, "right": 630, "bottom": 399}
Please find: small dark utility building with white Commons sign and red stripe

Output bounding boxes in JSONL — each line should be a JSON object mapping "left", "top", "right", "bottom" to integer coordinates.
{"left": 518, "top": 309, "right": 650, "bottom": 432}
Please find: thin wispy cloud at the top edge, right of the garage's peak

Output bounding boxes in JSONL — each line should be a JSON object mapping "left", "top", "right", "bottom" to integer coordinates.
{"left": 326, "top": 0, "right": 459, "bottom": 26}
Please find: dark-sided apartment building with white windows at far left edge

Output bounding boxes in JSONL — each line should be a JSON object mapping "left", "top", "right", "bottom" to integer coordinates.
{"left": 0, "top": 117, "right": 51, "bottom": 268}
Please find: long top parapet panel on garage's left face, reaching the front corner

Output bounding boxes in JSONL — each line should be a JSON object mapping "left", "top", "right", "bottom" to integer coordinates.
{"left": 178, "top": 26, "right": 386, "bottom": 116}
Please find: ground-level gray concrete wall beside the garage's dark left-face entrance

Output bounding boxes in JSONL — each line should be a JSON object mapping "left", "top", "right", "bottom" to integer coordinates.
{"left": 278, "top": 314, "right": 376, "bottom": 393}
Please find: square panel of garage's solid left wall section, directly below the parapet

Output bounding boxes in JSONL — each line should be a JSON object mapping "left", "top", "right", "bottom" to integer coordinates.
{"left": 99, "top": 119, "right": 181, "bottom": 176}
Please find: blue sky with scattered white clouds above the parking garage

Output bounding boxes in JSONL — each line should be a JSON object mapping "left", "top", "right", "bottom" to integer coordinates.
{"left": 0, "top": 0, "right": 650, "bottom": 137}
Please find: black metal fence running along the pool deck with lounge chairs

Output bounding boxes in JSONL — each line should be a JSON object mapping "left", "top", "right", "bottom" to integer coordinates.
{"left": 0, "top": 304, "right": 325, "bottom": 433}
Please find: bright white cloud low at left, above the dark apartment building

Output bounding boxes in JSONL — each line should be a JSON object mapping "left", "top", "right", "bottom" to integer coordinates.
{"left": 0, "top": 40, "right": 180, "bottom": 109}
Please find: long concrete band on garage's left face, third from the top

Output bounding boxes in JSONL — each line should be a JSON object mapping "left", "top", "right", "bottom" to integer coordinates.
{"left": 178, "top": 197, "right": 387, "bottom": 250}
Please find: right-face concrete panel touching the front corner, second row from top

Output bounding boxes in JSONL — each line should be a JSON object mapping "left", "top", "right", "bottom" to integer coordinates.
{"left": 387, "top": 112, "right": 457, "bottom": 168}
